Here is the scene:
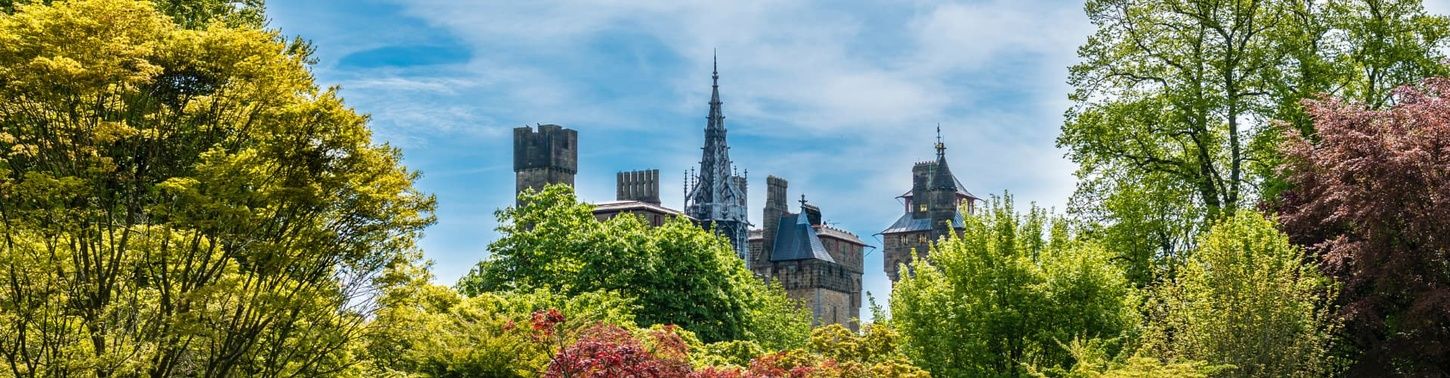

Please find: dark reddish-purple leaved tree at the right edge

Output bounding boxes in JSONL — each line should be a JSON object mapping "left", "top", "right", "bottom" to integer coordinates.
{"left": 1280, "top": 78, "right": 1450, "bottom": 375}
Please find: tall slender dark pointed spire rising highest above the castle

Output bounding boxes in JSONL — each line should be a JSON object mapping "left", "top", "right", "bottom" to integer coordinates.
{"left": 684, "top": 54, "right": 750, "bottom": 261}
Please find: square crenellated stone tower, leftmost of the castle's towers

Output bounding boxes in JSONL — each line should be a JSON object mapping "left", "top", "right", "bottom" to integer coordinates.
{"left": 513, "top": 125, "right": 579, "bottom": 201}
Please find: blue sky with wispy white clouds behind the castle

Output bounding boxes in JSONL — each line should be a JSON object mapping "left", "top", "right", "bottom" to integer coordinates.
{"left": 268, "top": 0, "right": 1446, "bottom": 316}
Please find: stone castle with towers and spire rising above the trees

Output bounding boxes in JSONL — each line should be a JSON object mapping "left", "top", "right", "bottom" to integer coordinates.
{"left": 513, "top": 55, "right": 976, "bottom": 330}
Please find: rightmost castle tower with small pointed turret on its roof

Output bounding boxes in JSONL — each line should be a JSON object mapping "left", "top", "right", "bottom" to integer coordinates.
{"left": 882, "top": 127, "right": 980, "bottom": 282}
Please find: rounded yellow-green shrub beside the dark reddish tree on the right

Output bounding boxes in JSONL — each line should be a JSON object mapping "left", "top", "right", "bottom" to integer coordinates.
{"left": 1140, "top": 210, "right": 1335, "bottom": 377}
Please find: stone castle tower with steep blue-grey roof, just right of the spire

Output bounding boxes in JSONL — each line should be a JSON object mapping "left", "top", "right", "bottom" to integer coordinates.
{"left": 747, "top": 177, "right": 866, "bottom": 330}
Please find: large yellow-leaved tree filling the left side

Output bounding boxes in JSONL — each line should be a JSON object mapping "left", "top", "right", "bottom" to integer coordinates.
{"left": 0, "top": 0, "right": 434, "bottom": 377}
